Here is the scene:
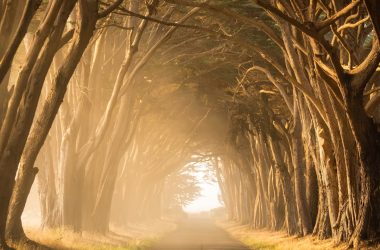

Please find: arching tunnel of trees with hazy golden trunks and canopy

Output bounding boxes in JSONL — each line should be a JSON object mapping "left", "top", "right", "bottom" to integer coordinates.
{"left": 0, "top": 0, "right": 380, "bottom": 249}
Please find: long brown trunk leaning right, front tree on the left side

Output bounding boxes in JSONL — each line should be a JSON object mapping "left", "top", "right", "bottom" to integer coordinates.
{"left": 5, "top": 1, "right": 97, "bottom": 240}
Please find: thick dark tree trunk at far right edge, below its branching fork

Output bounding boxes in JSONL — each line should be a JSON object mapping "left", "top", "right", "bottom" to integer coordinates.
{"left": 347, "top": 95, "right": 380, "bottom": 246}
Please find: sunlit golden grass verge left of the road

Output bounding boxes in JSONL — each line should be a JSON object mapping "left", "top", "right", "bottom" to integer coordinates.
{"left": 24, "top": 220, "right": 176, "bottom": 250}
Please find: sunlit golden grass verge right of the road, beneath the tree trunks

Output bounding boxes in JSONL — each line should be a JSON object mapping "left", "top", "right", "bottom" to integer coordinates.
{"left": 218, "top": 222, "right": 347, "bottom": 250}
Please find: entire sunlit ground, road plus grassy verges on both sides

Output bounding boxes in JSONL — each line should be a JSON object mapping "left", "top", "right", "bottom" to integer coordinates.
{"left": 24, "top": 215, "right": 380, "bottom": 250}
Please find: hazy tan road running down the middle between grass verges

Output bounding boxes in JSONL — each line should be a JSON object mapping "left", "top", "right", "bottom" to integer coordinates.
{"left": 152, "top": 217, "right": 248, "bottom": 250}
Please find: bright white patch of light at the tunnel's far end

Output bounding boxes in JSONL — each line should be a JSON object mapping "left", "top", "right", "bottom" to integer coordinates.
{"left": 184, "top": 163, "right": 223, "bottom": 213}
